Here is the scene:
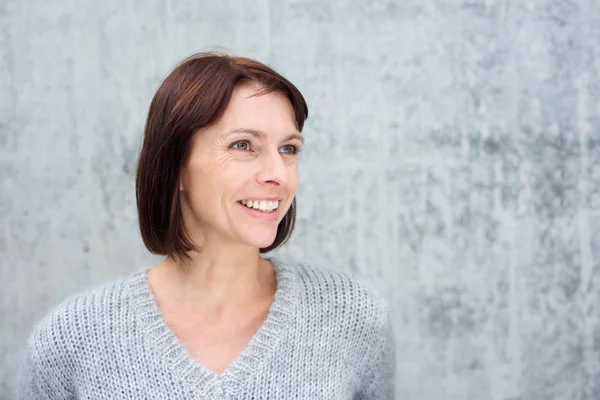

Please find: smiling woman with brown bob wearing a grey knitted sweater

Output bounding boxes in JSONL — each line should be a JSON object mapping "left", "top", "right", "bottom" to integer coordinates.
{"left": 20, "top": 53, "right": 395, "bottom": 399}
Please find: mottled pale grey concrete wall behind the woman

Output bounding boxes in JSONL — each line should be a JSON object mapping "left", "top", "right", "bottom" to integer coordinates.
{"left": 0, "top": 0, "right": 600, "bottom": 400}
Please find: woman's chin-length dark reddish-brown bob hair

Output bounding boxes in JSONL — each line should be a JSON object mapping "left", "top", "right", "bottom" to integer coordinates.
{"left": 136, "top": 52, "right": 308, "bottom": 260}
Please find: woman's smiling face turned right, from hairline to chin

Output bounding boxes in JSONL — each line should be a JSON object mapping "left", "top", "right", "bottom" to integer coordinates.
{"left": 180, "top": 85, "right": 302, "bottom": 252}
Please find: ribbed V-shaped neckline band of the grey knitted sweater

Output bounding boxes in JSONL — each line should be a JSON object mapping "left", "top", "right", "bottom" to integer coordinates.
{"left": 131, "top": 258, "right": 297, "bottom": 394}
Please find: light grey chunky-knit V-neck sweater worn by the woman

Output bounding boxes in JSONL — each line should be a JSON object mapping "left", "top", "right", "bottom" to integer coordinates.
{"left": 19, "top": 259, "right": 395, "bottom": 400}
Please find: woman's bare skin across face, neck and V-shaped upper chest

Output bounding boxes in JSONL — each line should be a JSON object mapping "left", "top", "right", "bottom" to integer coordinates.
{"left": 148, "top": 84, "right": 302, "bottom": 373}
